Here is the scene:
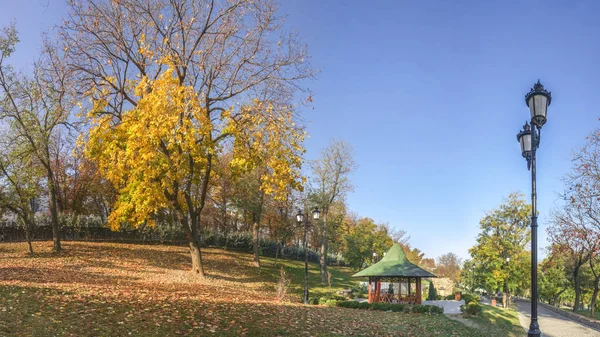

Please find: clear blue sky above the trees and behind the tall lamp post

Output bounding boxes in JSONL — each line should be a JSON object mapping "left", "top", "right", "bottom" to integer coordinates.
{"left": 0, "top": 0, "right": 600, "bottom": 257}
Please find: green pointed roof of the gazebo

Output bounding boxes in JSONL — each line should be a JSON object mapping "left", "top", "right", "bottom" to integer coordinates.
{"left": 352, "top": 243, "right": 436, "bottom": 277}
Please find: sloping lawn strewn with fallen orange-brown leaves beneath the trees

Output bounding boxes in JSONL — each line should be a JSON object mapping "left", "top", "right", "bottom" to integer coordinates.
{"left": 0, "top": 242, "right": 484, "bottom": 337}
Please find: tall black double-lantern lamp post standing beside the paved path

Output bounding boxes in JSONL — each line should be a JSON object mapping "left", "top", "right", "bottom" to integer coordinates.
{"left": 517, "top": 80, "right": 552, "bottom": 337}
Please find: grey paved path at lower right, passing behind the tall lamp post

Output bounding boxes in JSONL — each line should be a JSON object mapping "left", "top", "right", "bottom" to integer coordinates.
{"left": 517, "top": 301, "right": 600, "bottom": 337}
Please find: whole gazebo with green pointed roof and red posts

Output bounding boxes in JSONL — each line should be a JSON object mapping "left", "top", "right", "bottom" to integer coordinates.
{"left": 352, "top": 243, "right": 436, "bottom": 304}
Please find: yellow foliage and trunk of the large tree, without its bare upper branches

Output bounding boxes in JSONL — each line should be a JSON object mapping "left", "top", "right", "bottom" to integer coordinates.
{"left": 86, "top": 67, "right": 304, "bottom": 275}
